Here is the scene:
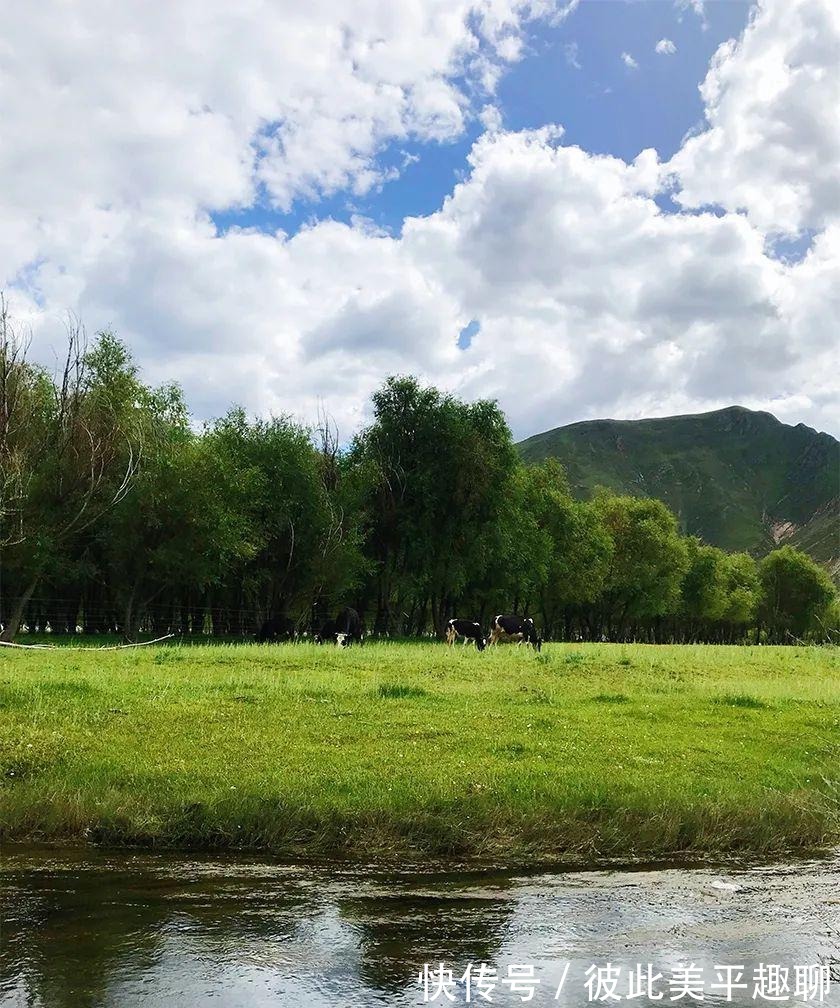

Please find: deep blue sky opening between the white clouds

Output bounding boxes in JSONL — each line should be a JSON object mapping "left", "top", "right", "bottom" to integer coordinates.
{"left": 213, "top": 0, "right": 750, "bottom": 234}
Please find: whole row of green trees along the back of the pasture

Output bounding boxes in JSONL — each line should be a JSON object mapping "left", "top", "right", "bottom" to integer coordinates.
{"left": 0, "top": 316, "right": 838, "bottom": 643}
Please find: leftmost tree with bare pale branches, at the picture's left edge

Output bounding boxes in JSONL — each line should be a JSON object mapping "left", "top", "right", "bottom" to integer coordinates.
{"left": 0, "top": 318, "right": 143, "bottom": 640}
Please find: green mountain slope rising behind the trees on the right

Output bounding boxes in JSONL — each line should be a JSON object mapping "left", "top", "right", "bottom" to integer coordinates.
{"left": 518, "top": 406, "right": 840, "bottom": 577}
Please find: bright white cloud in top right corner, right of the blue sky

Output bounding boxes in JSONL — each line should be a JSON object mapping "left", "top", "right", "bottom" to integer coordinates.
{"left": 671, "top": 0, "right": 840, "bottom": 235}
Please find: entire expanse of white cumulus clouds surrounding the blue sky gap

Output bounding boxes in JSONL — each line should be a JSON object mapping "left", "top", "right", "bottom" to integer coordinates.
{"left": 0, "top": 0, "right": 840, "bottom": 435}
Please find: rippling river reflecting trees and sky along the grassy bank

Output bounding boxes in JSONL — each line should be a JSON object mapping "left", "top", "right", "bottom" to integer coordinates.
{"left": 0, "top": 849, "right": 840, "bottom": 1008}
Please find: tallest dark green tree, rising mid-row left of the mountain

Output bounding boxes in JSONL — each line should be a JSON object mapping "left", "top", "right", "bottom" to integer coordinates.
{"left": 353, "top": 378, "right": 517, "bottom": 633}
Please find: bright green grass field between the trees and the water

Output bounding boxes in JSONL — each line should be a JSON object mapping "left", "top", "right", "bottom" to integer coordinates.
{"left": 0, "top": 644, "right": 840, "bottom": 863}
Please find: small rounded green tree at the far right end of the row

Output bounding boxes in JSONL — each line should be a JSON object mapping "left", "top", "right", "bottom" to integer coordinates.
{"left": 758, "top": 545, "right": 836, "bottom": 642}
